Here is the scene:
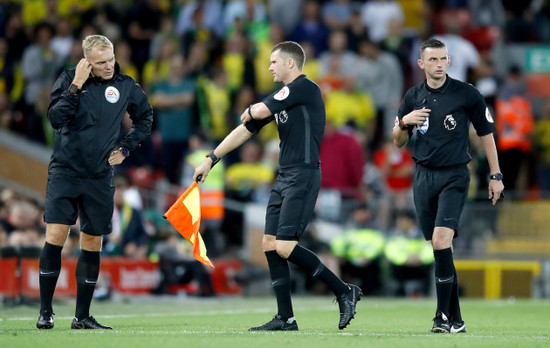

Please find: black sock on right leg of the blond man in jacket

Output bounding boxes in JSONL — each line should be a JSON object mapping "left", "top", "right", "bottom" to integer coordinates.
{"left": 75, "top": 250, "right": 99, "bottom": 320}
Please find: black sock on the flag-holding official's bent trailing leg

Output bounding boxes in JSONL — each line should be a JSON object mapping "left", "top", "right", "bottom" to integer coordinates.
{"left": 288, "top": 244, "right": 349, "bottom": 296}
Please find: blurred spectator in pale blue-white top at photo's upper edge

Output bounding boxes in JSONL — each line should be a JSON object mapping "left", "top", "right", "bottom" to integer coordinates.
{"left": 361, "top": 0, "right": 403, "bottom": 43}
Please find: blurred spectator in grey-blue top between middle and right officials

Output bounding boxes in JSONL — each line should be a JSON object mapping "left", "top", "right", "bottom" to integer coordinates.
{"left": 353, "top": 41, "right": 403, "bottom": 149}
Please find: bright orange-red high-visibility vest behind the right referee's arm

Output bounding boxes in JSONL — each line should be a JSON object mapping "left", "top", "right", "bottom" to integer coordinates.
{"left": 495, "top": 96, "right": 535, "bottom": 152}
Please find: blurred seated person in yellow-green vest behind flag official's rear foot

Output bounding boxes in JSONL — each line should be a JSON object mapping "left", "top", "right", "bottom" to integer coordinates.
{"left": 330, "top": 203, "right": 385, "bottom": 295}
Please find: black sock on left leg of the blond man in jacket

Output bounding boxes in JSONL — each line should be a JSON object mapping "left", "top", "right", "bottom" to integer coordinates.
{"left": 38, "top": 242, "right": 63, "bottom": 312}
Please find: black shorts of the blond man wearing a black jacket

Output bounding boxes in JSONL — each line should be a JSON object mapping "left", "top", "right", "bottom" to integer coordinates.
{"left": 44, "top": 174, "right": 115, "bottom": 236}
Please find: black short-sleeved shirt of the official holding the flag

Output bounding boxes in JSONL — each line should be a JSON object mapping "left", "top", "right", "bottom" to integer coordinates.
{"left": 247, "top": 75, "right": 326, "bottom": 168}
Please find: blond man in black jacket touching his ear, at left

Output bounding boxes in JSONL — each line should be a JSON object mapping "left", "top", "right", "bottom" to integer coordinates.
{"left": 36, "top": 35, "right": 153, "bottom": 329}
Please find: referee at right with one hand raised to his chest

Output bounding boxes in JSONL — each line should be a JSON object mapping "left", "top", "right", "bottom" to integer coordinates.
{"left": 393, "top": 39, "right": 504, "bottom": 333}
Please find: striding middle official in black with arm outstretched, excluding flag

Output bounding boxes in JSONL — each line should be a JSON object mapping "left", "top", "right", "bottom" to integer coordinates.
{"left": 193, "top": 41, "right": 362, "bottom": 331}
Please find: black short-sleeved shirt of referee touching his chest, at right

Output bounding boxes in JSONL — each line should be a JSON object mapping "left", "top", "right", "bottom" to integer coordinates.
{"left": 396, "top": 75, "right": 495, "bottom": 168}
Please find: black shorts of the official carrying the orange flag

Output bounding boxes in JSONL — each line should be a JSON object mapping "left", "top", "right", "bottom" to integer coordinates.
{"left": 265, "top": 167, "right": 321, "bottom": 241}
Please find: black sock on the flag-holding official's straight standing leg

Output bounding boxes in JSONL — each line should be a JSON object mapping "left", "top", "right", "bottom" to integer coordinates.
{"left": 265, "top": 250, "right": 294, "bottom": 320}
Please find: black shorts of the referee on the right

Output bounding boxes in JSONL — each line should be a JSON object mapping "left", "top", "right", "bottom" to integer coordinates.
{"left": 413, "top": 165, "right": 470, "bottom": 240}
